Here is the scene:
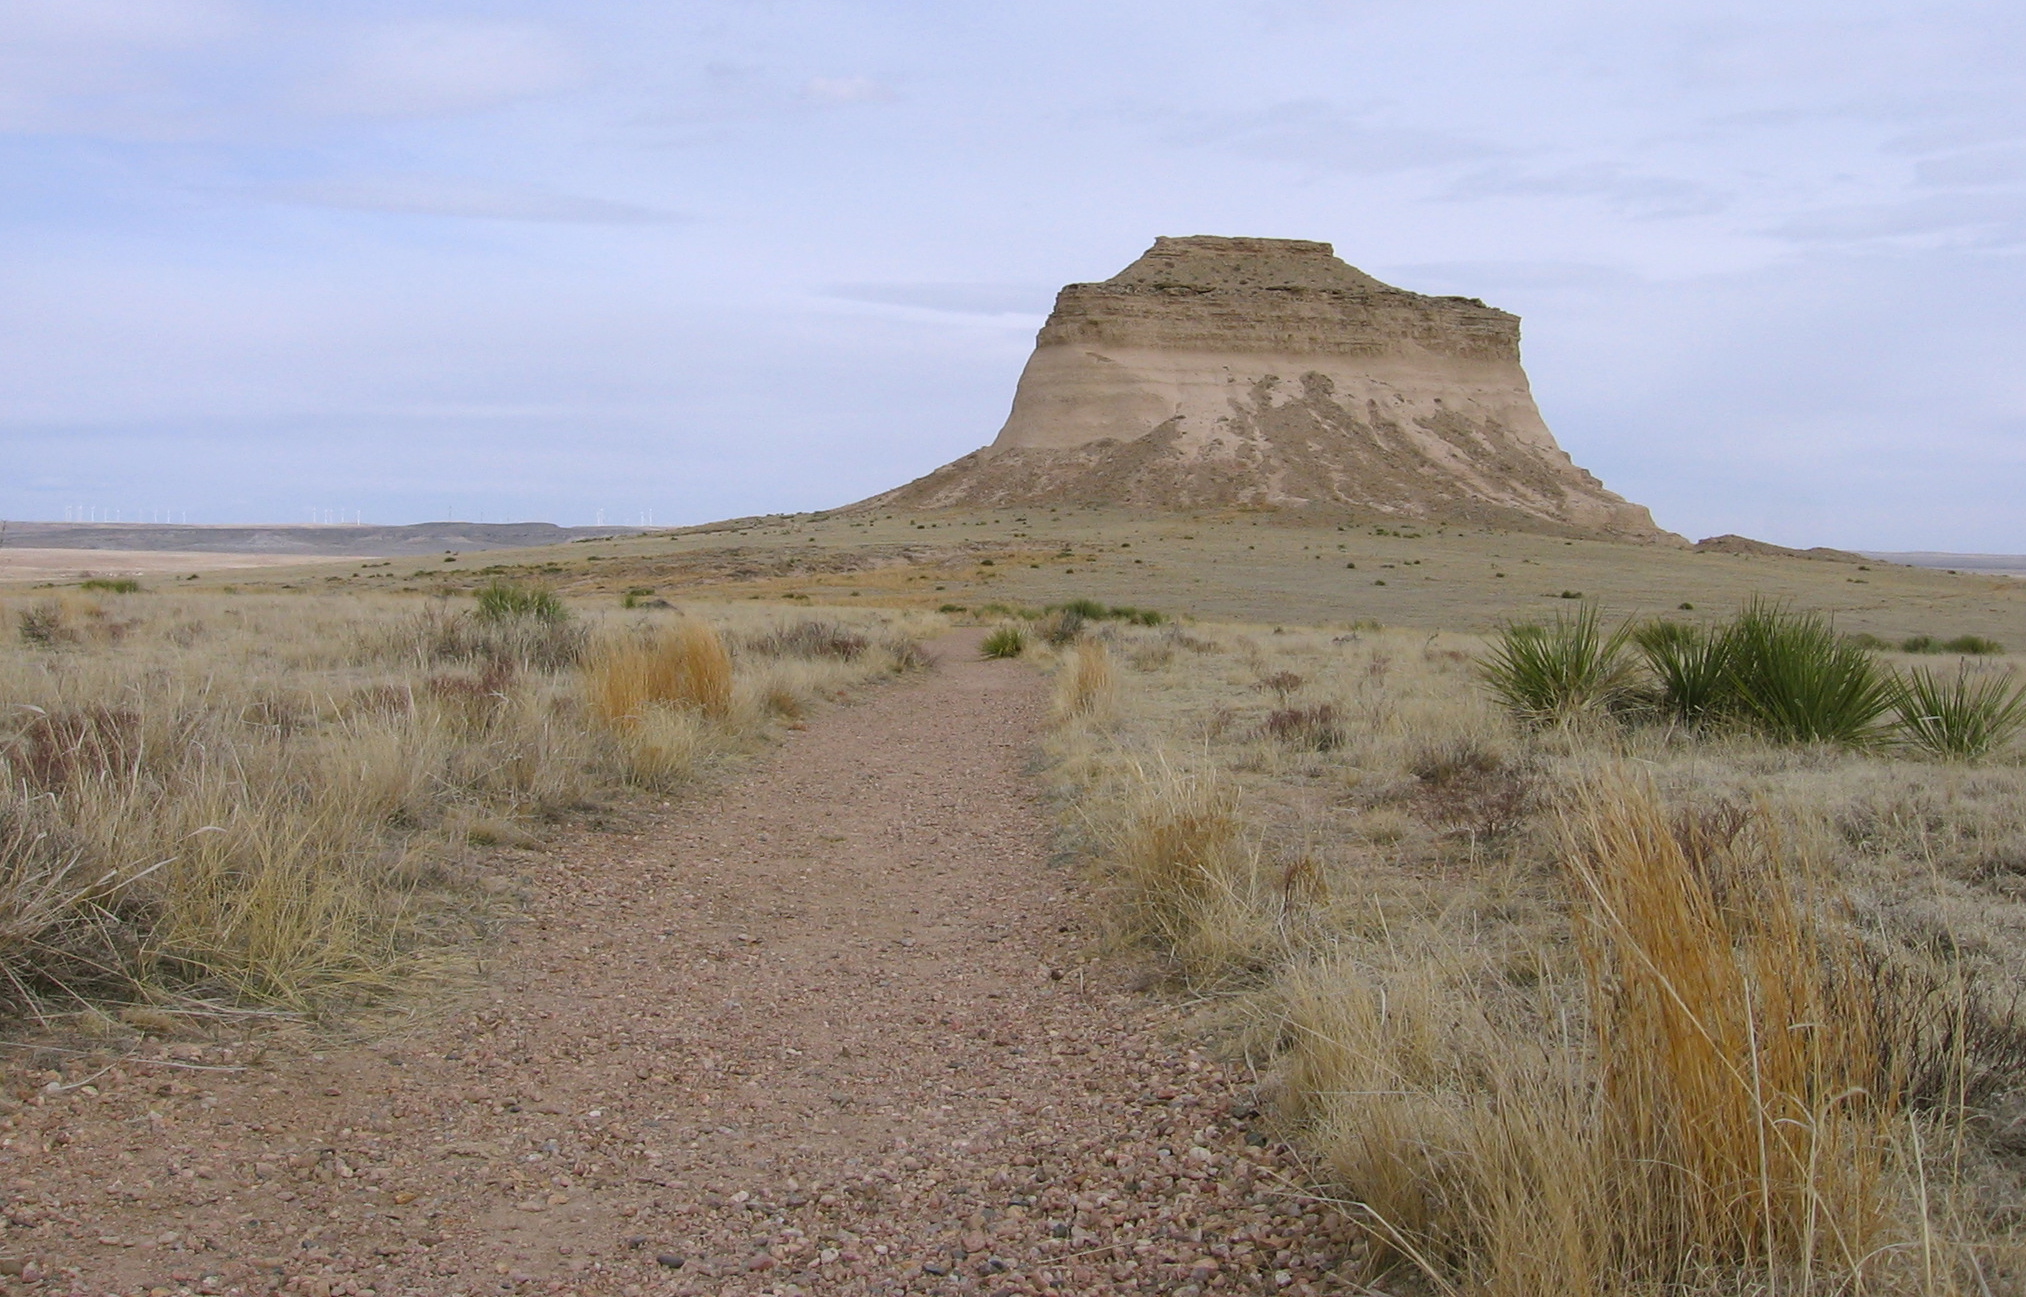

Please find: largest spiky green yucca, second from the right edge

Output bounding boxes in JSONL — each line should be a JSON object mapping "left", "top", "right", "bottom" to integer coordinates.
{"left": 1724, "top": 600, "right": 1894, "bottom": 746}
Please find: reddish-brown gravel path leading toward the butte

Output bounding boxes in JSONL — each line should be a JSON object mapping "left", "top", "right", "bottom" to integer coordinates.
{"left": 0, "top": 636, "right": 1347, "bottom": 1297}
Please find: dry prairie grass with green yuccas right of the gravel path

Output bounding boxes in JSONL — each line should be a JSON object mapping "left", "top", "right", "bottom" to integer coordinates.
{"left": 1054, "top": 606, "right": 2026, "bottom": 1297}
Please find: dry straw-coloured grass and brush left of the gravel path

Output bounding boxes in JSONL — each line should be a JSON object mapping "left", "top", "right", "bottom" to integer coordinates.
{"left": 0, "top": 586, "right": 920, "bottom": 1013}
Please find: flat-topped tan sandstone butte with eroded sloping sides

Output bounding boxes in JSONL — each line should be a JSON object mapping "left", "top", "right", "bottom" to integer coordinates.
{"left": 867, "top": 235, "right": 1676, "bottom": 539}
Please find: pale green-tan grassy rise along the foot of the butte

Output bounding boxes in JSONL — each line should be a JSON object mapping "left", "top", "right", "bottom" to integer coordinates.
{"left": 138, "top": 509, "right": 2026, "bottom": 646}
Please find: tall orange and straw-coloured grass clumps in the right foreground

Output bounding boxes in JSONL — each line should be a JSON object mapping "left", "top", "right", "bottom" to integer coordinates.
{"left": 1280, "top": 780, "right": 1925, "bottom": 1297}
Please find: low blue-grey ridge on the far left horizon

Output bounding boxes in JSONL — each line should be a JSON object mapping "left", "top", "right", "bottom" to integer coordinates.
{"left": 0, "top": 523, "right": 652, "bottom": 557}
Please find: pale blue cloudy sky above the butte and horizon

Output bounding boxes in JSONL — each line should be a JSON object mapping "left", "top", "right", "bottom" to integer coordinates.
{"left": 0, "top": 0, "right": 2026, "bottom": 553}
